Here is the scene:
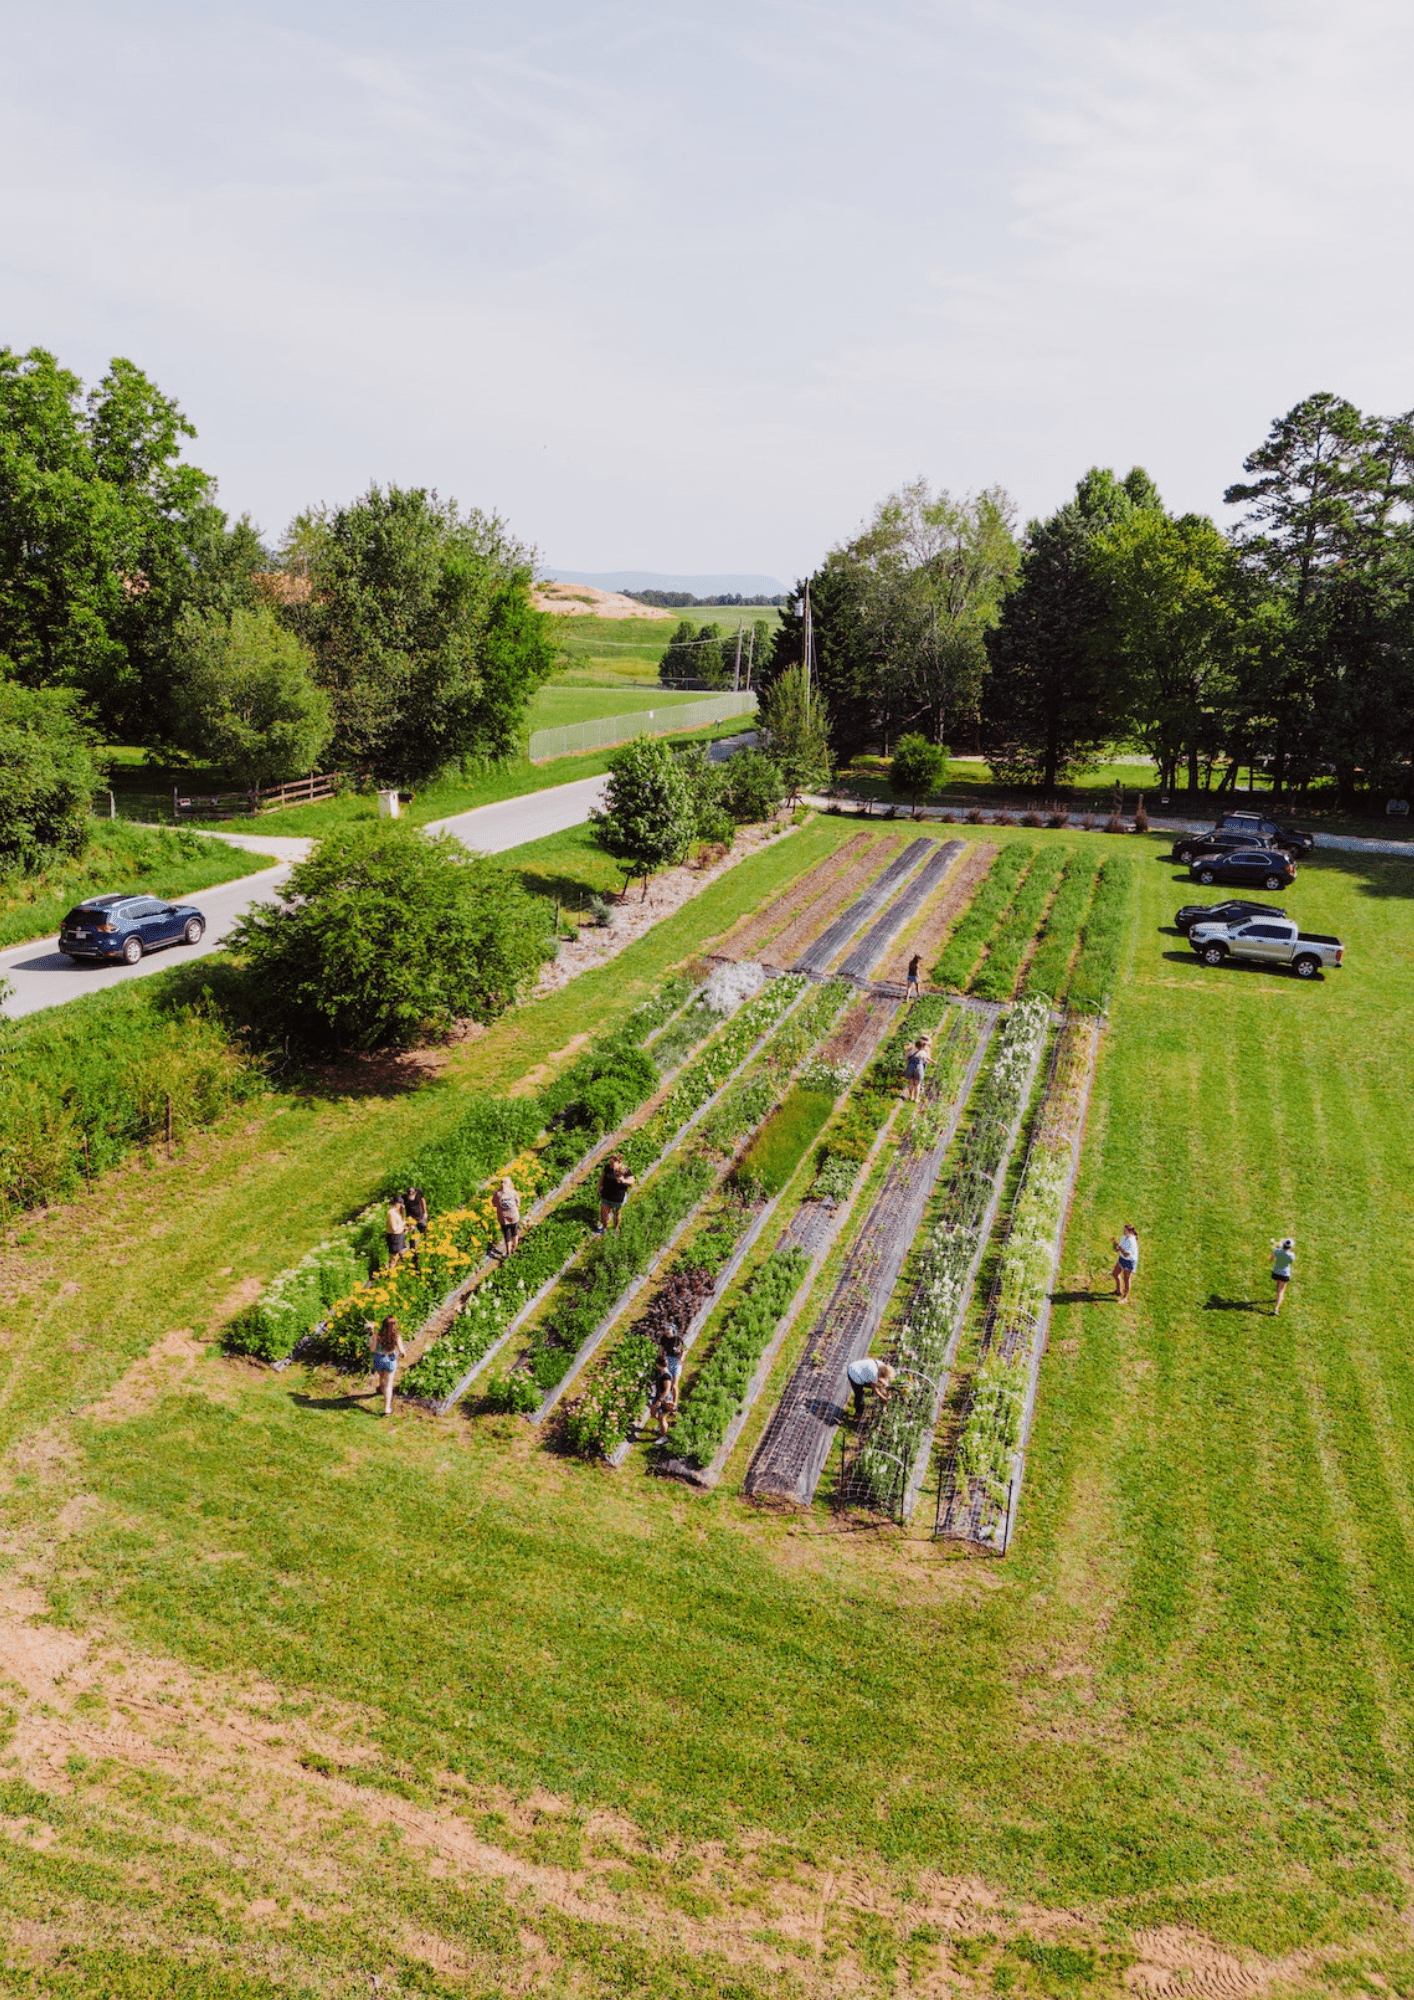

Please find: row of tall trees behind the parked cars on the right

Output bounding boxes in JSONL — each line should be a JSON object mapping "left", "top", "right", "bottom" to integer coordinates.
{"left": 760, "top": 394, "right": 1414, "bottom": 806}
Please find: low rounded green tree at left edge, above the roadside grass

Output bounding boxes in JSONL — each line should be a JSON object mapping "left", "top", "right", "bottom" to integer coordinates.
{"left": 0, "top": 684, "right": 98, "bottom": 868}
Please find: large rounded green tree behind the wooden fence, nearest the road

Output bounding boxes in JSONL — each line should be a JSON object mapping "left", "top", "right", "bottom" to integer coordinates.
{"left": 284, "top": 486, "right": 554, "bottom": 784}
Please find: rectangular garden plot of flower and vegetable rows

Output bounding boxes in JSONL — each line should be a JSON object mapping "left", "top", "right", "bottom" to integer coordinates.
{"left": 228, "top": 820, "right": 1132, "bottom": 1550}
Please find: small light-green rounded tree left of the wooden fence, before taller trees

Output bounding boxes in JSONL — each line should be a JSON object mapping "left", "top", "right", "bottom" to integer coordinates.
{"left": 172, "top": 606, "right": 332, "bottom": 786}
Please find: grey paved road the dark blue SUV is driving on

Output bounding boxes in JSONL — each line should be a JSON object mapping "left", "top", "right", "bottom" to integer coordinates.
{"left": 0, "top": 778, "right": 620, "bottom": 1018}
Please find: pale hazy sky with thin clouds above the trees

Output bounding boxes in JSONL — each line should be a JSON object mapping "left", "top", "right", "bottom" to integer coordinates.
{"left": 0, "top": 0, "right": 1414, "bottom": 578}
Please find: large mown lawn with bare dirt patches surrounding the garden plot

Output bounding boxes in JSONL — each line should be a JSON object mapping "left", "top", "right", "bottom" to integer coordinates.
{"left": 0, "top": 820, "right": 1414, "bottom": 2000}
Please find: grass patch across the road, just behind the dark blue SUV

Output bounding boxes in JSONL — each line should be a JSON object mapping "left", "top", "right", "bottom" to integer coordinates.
{"left": 0, "top": 820, "right": 274, "bottom": 946}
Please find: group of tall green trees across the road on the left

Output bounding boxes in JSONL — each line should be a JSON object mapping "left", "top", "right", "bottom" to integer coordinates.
{"left": 0, "top": 348, "right": 554, "bottom": 858}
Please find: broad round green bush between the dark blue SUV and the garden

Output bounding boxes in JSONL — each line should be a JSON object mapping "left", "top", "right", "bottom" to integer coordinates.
{"left": 230, "top": 820, "right": 554, "bottom": 1056}
